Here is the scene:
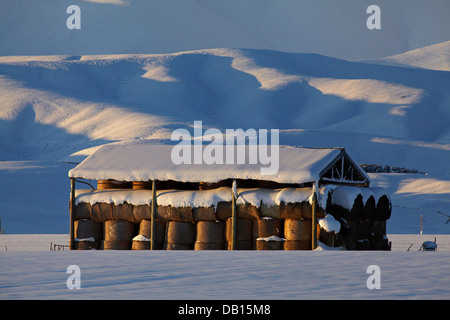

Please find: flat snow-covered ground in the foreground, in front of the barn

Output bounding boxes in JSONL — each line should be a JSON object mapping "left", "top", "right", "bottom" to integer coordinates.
{"left": 0, "top": 235, "right": 450, "bottom": 300}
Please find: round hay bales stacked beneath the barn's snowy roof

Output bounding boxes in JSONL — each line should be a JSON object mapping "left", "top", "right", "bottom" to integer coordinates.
{"left": 74, "top": 182, "right": 391, "bottom": 250}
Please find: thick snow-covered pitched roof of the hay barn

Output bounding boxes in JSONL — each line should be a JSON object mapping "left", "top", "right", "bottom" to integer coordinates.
{"left": 69, "top": 144, "right": 369, "bottom": 184}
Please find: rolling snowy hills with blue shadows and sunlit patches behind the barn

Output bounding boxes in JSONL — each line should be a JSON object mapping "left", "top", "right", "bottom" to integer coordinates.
{"left": 0, "top": 49, "right": 450, "bottom": 172}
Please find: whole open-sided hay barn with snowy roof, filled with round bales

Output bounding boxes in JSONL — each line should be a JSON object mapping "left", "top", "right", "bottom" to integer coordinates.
{"left": 69, "top": 144, "right": 391, "bottom": 250}
